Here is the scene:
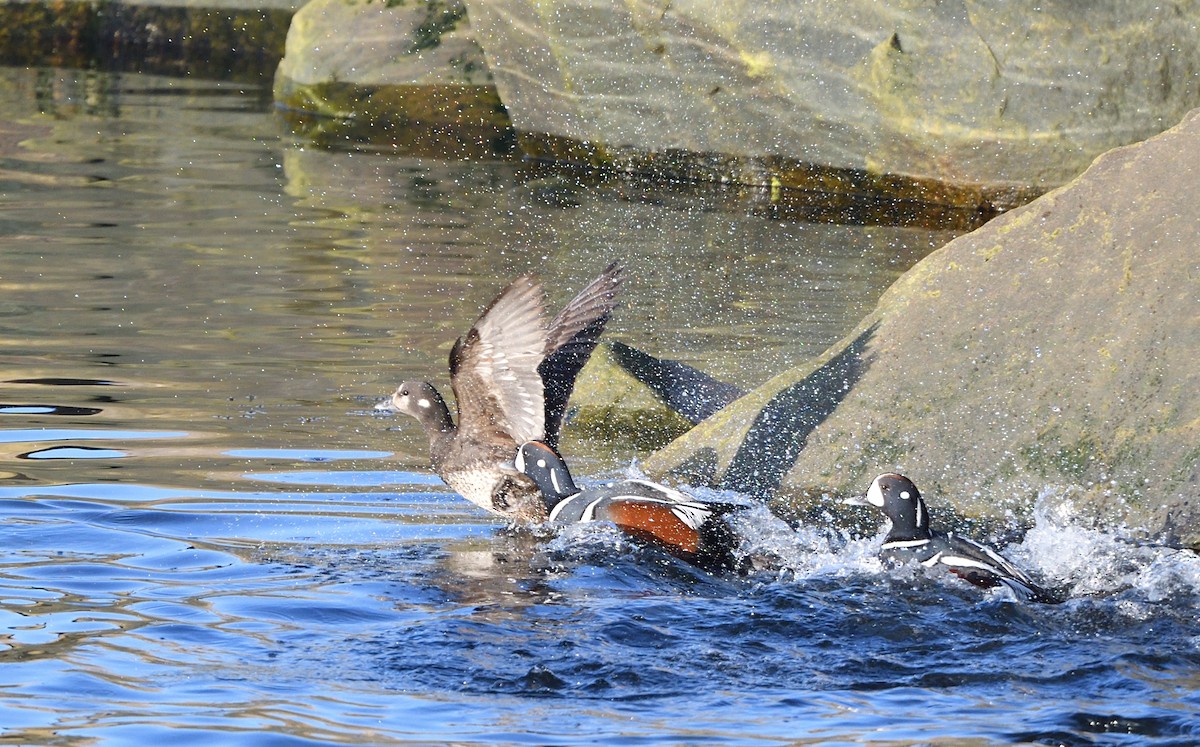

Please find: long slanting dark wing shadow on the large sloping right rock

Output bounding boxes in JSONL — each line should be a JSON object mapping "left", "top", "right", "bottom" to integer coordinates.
{"left": 718, "top": 325, "right": 875, "bottom": 498}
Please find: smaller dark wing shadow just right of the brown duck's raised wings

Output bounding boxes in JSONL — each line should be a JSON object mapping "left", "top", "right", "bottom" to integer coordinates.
{"left": 610, "top": 342, "right": 745, "bottom": 425}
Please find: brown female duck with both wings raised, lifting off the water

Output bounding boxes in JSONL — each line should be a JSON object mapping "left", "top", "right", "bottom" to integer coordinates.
{"left": 378, "top": 262, "right": 624, "bottom": 521}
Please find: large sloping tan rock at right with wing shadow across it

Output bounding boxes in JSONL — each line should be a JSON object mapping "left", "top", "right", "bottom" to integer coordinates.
{"left": 646, "top": 105, "right": 1200, "bottom": 548}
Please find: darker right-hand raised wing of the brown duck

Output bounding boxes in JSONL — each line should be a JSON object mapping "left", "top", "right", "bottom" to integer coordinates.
{"left": 539, "top": 262, "right": 624, "bottom": 447}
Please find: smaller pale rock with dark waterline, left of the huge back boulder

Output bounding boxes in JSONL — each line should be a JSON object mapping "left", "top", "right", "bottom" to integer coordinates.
{"left": 275, "top": 0, "right": 512, "bottom": 157}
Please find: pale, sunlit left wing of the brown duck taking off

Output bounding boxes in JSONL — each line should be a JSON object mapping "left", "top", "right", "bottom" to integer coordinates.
{"left": 450, "top": 275, "right": 547, "bottom": 443}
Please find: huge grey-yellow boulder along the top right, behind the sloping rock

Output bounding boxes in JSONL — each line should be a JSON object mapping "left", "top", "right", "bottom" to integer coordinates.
{"left": 466, "top": 0, "right": 1200, "bottom": 208}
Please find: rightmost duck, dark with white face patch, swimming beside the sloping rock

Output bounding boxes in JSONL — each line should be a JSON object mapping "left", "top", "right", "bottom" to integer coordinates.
{"left": 844, "top": 473, "right": 1063, "bottom": 604}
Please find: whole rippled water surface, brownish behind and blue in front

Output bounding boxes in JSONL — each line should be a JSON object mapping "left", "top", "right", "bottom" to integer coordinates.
{"left": 0, "top": 70, "right": 1200, "bottom": 745}
